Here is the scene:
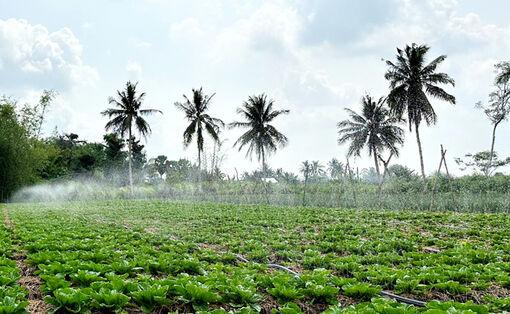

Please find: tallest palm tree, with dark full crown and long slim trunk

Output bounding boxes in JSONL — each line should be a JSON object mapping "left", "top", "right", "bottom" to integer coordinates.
{"left": 384, "top": 44, "right": 455, "bottom": 179}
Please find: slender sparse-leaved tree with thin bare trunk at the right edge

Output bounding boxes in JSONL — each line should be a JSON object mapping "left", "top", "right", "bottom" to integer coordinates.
{"left": 476, "top": 63, "right": 510, "bottom": 175}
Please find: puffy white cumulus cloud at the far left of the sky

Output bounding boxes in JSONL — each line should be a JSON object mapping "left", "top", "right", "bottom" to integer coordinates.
{"left": 0, "top": 19, "right": 98, "bottom": 89}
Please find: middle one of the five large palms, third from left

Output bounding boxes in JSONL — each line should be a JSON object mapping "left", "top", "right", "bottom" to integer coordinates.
{"left": 229, "top": 94, "right": 289, "bottom": 174}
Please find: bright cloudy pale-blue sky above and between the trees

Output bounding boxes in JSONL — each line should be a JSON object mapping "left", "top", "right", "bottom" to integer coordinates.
{"left": 0, "top": 0, "right": 510, "bottom": 174}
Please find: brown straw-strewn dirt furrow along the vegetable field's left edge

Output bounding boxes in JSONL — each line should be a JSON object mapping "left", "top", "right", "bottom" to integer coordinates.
{"left": 3, "top": 204, "right": 51, "bottom": 313}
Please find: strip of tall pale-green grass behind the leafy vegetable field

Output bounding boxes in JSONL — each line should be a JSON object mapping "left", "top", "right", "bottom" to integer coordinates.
{"left": 13, "top": 182, "right": 510, "bottom": 213}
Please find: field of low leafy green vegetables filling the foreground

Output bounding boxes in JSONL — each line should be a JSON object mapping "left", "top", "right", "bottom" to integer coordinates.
{"left": 0, "top": 200, "right": 510, "bottom": 313}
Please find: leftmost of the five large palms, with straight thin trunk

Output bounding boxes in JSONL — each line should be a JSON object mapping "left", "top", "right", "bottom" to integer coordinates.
{"left": 101, "top": 81, "right": 162, "bottom": 195}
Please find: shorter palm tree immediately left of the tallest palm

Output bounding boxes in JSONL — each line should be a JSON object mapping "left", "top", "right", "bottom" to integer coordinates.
{"left": 338, "top": 95, "right": 404, "bottom": 176}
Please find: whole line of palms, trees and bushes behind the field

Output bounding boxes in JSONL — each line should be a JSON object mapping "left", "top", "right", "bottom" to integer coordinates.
{"left": 0, "top": 44, "right": 510, "bottom": 200}
